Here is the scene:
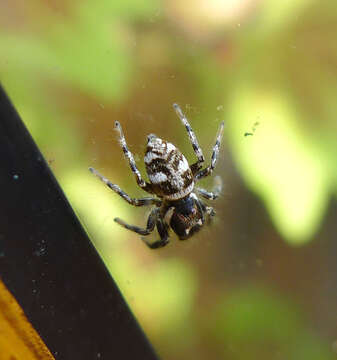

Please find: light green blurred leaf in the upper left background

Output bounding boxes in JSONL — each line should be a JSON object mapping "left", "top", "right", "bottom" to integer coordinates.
{"left": 0, "top": 1, "right": 158, "bottom": 101}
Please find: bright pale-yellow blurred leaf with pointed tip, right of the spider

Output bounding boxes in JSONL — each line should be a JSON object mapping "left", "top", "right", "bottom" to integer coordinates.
{"left": 229, "top": 87, "right": 329, "bottom": 244}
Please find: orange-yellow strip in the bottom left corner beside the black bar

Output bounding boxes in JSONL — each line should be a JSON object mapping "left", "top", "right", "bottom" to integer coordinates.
{"left": 0, "top": 280, "right": 55, "bottom": 360}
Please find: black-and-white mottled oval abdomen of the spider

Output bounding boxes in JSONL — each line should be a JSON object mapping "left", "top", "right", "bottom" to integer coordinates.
{"left": 144, "top": 134, "right": 194, "bottom": 200}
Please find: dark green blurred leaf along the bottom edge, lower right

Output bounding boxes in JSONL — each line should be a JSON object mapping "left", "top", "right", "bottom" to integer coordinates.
{"left": 212, "top": 287, "right": 334, "bottom": 360}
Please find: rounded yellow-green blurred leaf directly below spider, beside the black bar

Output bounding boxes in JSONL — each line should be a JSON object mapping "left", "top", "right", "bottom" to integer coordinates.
{"left": 119, "top": 258, "right": 196, "bottom": 337}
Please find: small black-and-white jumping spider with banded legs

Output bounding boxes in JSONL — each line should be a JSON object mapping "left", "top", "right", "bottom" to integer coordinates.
{"left": 89, "top": 104, "right": 224, "bottom": 249}
